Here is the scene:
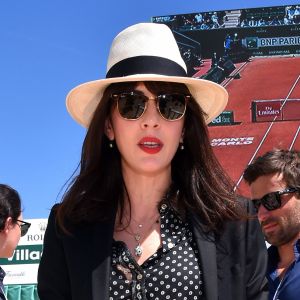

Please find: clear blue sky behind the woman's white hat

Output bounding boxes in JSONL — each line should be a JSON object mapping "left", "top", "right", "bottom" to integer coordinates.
{"left": 0, "top": 0, "right": 299, "bottom": 219}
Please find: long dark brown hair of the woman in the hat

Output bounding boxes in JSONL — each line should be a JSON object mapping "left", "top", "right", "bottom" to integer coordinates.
{"left": 57, "top": 81, "right": 241, "bottom": 232}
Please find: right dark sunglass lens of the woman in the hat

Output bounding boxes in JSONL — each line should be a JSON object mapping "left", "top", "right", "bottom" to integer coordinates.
{"left": 158, "top": 94, "right": 186, "bottom": 120}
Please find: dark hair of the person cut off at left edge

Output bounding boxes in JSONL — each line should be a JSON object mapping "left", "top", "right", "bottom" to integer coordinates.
{"left": 0, "top": 184, "right": 21, "bottom": 231}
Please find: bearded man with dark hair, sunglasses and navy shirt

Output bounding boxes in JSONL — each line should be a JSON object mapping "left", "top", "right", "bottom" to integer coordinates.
{"left": 244, "top": 149, "right": 300, "bottom": 300}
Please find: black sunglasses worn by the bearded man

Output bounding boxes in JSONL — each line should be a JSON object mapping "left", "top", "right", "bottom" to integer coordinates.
{"left": 252, "top": 188, "right": 299, "bottom": 212}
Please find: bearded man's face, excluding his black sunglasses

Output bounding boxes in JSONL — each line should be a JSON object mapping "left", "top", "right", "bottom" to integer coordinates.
{"left": 250, "top": 174, "right": 300, "bottom": 246}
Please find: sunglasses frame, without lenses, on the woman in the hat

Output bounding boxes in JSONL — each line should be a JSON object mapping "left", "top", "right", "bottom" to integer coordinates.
{"left": 111, "top": 92, "right": 192, "bottom": 122}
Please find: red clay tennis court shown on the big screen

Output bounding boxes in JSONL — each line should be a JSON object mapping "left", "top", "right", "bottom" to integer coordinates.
{"left": 205, "top": 56, "right": 300, "bottom": 196}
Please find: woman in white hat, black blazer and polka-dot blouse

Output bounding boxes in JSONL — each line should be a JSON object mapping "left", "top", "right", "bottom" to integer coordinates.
{"left": 38, "top": 23, "right": 266, "bottom": 300}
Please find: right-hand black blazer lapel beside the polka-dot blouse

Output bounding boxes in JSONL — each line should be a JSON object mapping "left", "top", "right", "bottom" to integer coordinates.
{"left": 190, "top": 215, "right": 218, "bottom": 300}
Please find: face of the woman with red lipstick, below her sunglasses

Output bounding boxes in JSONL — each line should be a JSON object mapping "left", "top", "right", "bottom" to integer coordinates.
{"left": 106, "top": 83, "right": 184, "bottom": 175}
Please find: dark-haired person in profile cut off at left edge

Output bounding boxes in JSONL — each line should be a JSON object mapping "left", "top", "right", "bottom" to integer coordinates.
{"left": 0, "top": 184, "right": 30, "bottom": 299}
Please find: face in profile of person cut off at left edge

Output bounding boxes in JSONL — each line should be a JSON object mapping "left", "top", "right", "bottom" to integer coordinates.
{"left": 0, "top": 214, "right": 23, "bottom": 258}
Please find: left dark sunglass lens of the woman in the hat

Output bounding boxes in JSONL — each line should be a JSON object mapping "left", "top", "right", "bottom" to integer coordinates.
{"left": 118, "top": 93, "right": 147, "bottom": 120}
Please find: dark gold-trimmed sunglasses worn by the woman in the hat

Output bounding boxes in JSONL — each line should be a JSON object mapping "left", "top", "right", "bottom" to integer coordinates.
{"left": 111, "top": 92, "right": 191, "bottom": 121}
